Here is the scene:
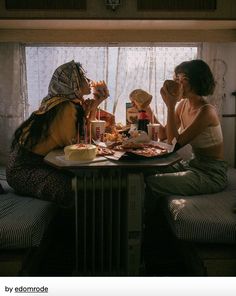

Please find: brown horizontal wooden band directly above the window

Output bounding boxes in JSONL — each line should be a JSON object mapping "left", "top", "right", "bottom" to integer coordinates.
{"left": 0, "top": 29, "right": 236, "bottom": 43}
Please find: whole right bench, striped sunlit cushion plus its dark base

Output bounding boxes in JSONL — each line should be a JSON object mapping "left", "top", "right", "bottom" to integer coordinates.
{"left": 162, "top": 168, "right": 236, "bottom": 276}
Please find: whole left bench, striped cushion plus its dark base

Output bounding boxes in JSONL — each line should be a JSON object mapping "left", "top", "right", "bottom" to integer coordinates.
{"left": 0, "top": 168, "right": 57, "bottom": 276}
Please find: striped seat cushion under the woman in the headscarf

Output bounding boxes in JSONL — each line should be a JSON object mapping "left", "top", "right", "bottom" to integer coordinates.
{"left": 0, "top": 181, "right": 55, "bottom": 249}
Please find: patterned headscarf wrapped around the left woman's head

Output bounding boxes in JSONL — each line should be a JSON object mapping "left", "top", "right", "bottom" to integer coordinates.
{"left": 34, "top": 60, "right": 87, "bottom": 115}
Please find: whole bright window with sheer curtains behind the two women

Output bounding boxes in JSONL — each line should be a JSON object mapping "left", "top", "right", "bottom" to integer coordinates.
{"left": 26, "top": 44, "right": 198, "bottom": 124}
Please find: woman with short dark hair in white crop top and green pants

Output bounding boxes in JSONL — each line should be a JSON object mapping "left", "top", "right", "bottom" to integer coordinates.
{"left": 147, "top": 60, "right": 227, "bottom": 196}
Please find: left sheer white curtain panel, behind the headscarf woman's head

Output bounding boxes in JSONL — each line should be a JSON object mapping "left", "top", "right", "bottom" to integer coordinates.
{"left": 26, "top": 46, "right": 107, "bottom": 114}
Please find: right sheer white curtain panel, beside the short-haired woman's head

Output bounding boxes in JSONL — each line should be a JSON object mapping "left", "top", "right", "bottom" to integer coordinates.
{"left": 113, "top": 45, "right": 198, "bottom": 123}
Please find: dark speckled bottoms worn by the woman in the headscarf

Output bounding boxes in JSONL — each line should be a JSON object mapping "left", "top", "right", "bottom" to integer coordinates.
{"left": 6, "top": 147, "right": 74, "bottom": 207}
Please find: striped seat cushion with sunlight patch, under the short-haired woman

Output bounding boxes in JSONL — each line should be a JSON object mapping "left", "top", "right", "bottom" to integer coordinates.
{"left": 164, "top": 190, "right": 236, "bottom": 243}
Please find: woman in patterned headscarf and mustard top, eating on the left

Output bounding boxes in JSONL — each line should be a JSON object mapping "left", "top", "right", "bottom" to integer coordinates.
{"left": 6, "top": 61, "right": 109, "bottom": 206}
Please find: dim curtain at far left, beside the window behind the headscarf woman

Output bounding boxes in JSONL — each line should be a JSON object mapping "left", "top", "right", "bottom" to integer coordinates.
{"left": 0, "top": 43, "right": 26, "bottom": 164}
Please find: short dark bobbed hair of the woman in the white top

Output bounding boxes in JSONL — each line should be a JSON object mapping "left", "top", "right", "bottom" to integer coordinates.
{"left": 175, "top": 60, "right": 215, "bottom": 96}
